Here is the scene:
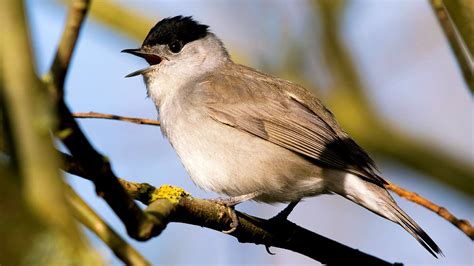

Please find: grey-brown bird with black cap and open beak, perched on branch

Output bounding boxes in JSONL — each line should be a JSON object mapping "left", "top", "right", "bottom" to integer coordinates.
{"left": 122, "top": 16, "right": 442, "bottom": 257}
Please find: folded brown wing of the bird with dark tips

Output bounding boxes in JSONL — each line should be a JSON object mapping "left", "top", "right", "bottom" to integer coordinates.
{"left": 197, "top": 63, "right": 386, "bottom": 186}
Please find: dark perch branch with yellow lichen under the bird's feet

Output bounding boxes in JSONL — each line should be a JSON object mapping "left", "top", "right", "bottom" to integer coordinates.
{"left": 63, "top": 154, "right": 401, "bottom": 265}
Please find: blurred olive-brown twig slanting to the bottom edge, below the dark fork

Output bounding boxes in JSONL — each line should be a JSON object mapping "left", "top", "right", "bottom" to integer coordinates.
{"left": 66, "top": 186, "right": 150, "bottom": 265}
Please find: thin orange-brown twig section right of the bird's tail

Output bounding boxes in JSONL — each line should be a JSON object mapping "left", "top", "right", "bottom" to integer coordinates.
{"left": 385, "top": 182, "right": 474, "bottom": 240}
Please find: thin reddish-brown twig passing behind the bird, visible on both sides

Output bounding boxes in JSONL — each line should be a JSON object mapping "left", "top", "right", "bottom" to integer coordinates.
{"left": 70, "top": 112, "right": 474, "bottom": 240}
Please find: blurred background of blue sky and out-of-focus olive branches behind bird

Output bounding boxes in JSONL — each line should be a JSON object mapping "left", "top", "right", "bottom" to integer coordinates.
{"left": 20, "top": 0, "right": 474, "bottom": 265}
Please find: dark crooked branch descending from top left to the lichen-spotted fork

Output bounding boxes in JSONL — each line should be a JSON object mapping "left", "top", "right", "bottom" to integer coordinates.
{"left": 44, "top": 0, "right": 161, "bottom": 240}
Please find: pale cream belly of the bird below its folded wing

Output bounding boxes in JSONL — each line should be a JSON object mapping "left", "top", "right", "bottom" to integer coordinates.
{"left": 164, "top": 114, "right": 324, "bottom": 202}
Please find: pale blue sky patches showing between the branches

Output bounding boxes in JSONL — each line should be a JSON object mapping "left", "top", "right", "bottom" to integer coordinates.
{"left": 27, "top": 0, "right": 474, "bottom": 265}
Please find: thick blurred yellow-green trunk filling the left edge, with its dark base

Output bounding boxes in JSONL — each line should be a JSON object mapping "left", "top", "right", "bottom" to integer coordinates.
{"left": 0, "top": 0, "right": 101, "bottom": 265}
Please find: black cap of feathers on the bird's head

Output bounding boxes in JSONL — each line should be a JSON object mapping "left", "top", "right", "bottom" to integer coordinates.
{"left": 142, "top": 16, "right": 209, "bottom": 47}
